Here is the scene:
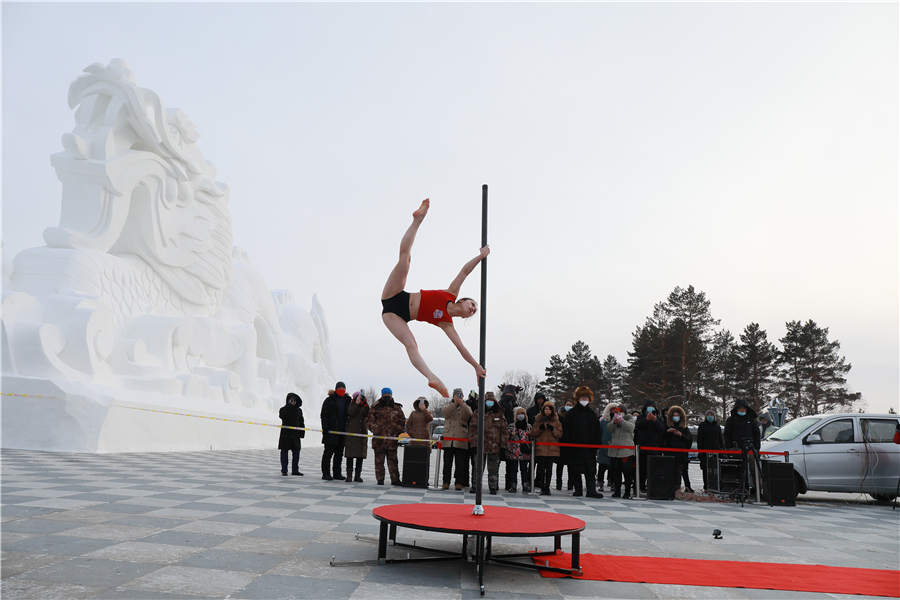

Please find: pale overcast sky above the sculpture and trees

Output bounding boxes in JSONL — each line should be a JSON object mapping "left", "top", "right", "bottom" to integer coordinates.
{"left": 2, "top": 3, "right": 900, "bottom": 411}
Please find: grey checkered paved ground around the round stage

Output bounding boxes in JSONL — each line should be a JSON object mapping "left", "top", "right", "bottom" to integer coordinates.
{"left": 2, "top": 447, "right": 900, "bottom": 599}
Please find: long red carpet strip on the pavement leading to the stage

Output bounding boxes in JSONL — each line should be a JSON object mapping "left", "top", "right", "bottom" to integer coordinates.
{"left": 534, "top": 553, "right": 900, "bottom": 598}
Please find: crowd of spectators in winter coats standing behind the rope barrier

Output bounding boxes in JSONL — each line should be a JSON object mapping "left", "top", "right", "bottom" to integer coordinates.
{"left": 278, "top": 381, "right": 771, "bottom": 499}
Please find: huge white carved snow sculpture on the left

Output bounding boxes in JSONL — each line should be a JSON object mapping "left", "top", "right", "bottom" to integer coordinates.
{"left": 2, "top": 59, "right": 334, "bottom": 452}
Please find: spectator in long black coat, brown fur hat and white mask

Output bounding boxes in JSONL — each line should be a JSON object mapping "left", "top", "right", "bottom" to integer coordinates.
{"left": 560, "top": 386, "right": 603, "bottom": 498}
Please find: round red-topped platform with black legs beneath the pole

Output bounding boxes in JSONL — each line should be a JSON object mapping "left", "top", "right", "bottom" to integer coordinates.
{"left": 364, "top": 503, "right": 585, "bottom": 595}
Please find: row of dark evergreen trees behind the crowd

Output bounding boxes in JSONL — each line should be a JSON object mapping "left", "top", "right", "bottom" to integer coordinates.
{"left": 540, "top": 286, "right": 861, "bottom": 419}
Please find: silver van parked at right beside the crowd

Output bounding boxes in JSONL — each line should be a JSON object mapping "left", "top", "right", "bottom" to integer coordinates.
{"left": 762, "top": 413, "right": 900, "bottom": 502}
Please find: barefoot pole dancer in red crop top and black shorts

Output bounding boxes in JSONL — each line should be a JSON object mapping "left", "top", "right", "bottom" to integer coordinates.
{"left": 381, "top": 198, "right": 491, "bottom": 398}
